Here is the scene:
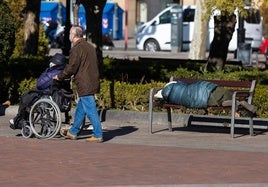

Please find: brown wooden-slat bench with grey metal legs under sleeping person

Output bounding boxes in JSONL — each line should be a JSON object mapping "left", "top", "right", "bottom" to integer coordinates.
{"left": 149, "top": 77, "right": 256, "bottom": 138}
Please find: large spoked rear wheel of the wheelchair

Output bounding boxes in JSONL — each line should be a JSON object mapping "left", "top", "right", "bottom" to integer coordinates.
{"left": 29, "top": 98, "right": 61, "bottom": 139}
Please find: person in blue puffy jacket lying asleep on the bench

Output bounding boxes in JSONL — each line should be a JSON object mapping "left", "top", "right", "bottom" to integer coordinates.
{"left": 154, "top": 81, "right": 257, "bottom": 113}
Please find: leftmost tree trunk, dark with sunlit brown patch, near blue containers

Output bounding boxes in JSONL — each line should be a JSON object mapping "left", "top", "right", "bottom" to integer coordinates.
{"left": 23, "top": 0, "right": 40, "bottom": 55}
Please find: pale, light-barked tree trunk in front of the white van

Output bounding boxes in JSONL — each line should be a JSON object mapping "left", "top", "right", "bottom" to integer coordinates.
{"left": 189, "top": 0, "right": 208, "bottom": 59}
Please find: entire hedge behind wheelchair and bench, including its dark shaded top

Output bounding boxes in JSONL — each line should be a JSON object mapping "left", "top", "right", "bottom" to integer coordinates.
{"left": 4, "top": 57, "right": 268, "bottom": 117}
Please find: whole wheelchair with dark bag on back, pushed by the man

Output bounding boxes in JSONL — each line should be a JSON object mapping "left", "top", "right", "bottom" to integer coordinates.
{"left": 21, "top": 80, "right": 74, "bottom": 139}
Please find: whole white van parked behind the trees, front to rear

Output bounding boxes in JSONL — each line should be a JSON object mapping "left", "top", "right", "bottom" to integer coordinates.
{"left": 136, "top": 5, "right": 262, "bottom": 51}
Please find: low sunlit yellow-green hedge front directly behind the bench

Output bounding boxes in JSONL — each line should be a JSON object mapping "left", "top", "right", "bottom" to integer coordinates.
{"left": 14, "top": 76, "right": 268, "bottom": 117}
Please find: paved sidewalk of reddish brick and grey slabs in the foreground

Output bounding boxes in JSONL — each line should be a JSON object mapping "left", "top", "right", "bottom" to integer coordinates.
{"left": 0, "top": 106, "right": 268, "bottom": 187}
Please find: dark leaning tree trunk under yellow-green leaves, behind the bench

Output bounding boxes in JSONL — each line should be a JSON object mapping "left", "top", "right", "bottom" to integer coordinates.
{"left": 206, "top": 14, "right": 236, "bottom": 71}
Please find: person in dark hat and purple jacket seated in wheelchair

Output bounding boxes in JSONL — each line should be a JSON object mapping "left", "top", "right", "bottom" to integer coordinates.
{"left": 9, "top": 53, "right": 66, "bottom": 129}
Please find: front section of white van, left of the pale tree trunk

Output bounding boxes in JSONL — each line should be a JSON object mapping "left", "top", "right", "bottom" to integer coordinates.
{"left": 136, "top": 5, "right": 195, "bottom": 51}
